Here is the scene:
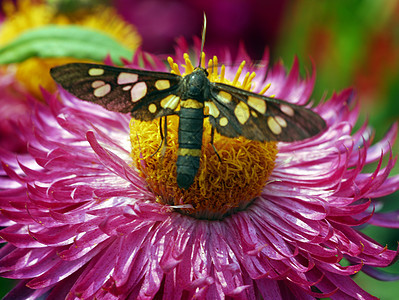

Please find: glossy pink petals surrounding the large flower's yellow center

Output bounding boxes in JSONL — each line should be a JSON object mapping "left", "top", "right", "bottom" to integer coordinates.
{"left": 0, "top": 44, "right": 399, "bottom": 299}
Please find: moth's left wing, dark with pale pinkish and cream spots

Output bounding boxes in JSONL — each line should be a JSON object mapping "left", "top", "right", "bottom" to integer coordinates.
{"left": 50, "top": 63, "right": 182, "bottom": 121}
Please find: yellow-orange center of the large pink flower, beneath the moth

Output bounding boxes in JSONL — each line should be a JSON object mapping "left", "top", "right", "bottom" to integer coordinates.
{"left": 130, "top": 54, "right": 278, "bottom": 219}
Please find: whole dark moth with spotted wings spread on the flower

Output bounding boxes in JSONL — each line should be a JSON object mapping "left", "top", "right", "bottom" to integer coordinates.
{"left": 51, "top": 18, "right": 326, "bottom": 189}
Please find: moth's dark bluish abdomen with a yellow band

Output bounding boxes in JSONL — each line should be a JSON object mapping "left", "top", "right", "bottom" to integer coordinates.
{"left": 176, "top": 107, "right": 204, "bottom": 189}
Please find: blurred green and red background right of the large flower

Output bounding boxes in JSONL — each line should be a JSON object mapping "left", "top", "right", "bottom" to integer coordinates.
{"left": 273, "top": 0, "right": 399, "bottom": 300}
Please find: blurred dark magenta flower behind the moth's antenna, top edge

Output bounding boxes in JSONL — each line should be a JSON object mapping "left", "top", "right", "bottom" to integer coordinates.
{"left": 114, "top": 0, "right": 287, "bottom": 58}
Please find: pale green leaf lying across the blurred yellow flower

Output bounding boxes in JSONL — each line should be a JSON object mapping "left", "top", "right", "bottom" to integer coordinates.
{"left": 0, "top": 25, "right": 133, "bottom": 65}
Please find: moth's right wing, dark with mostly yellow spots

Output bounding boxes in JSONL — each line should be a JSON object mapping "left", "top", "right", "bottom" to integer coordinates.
{"left": 205, "top": 83, "right": 326, "bottom": 142}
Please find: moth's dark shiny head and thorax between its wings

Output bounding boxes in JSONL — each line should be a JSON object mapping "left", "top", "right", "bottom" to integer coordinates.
{"left": 182, "top": 68, "right": 209, "bottom": 102}
